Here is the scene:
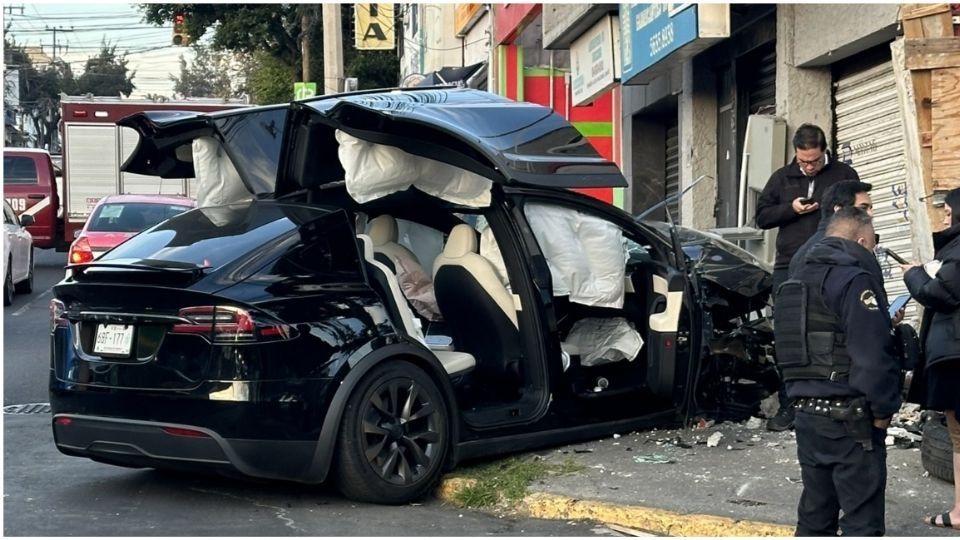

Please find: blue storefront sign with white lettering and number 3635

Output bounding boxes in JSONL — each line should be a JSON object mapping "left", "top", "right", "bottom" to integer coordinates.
{"left": 620, "top": 3, "right": 730, "bottom": 84}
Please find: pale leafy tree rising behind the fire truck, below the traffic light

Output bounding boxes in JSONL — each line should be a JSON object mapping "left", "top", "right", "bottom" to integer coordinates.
{"left": 170, "top": 45, "right": 246, "bottom": 99}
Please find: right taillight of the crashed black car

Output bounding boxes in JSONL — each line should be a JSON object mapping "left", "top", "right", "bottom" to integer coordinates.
{"left": 170, "top": 306, "right": 296, "bottom": 343}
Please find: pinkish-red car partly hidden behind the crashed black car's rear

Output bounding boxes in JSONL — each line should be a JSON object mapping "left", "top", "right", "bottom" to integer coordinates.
{"left": 67, "top": 195, "right": 197, "bottom": 264}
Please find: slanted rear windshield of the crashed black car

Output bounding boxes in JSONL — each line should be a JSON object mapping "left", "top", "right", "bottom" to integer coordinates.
{"left": 98, "top": 202, "right": 327, "bottom": 268}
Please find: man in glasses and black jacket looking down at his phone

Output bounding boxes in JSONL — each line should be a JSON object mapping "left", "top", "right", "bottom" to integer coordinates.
{"left": 756, "top": 124, "right": 860, "bottom": 431}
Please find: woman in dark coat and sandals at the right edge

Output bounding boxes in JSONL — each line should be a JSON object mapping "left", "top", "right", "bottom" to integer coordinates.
{"left": 901, "top": 188, "right": 960, "bottom": 529}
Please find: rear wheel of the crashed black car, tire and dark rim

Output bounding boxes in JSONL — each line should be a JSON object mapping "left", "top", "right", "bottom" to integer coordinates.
{"left": 335, "top": 361, "right": 451, "bottom": 504}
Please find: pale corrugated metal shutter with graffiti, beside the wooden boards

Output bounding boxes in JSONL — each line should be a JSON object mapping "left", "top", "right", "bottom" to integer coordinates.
{"left": 834, "top": 61, "right": 916, "bottom": 320}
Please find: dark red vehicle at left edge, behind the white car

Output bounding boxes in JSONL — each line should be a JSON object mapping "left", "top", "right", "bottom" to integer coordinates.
{"left": 3, "top": 148, "right": 63, "bottom": 248}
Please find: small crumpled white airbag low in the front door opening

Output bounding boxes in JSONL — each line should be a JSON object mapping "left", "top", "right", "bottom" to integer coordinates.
{"left": 563, "top": 317, "right": 643, "bottom": 367}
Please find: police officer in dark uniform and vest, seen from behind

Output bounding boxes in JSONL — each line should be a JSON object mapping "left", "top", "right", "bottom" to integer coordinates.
{"left": 774, "top": 207, "right": 900, "bottom": 536}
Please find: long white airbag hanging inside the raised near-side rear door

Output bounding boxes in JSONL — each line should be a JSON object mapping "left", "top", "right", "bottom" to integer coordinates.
{"left": 336, "top": 130, "right": 493, "bottom": 208}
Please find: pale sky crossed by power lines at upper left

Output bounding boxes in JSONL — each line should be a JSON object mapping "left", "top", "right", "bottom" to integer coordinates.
{"left": 3, "top": 0, "right": 202, "bottom": 98}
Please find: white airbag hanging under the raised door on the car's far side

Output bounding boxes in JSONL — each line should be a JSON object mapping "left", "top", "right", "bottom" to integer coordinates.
{"left": 193, "top": 137, "right": 251, "bottom": 207}
